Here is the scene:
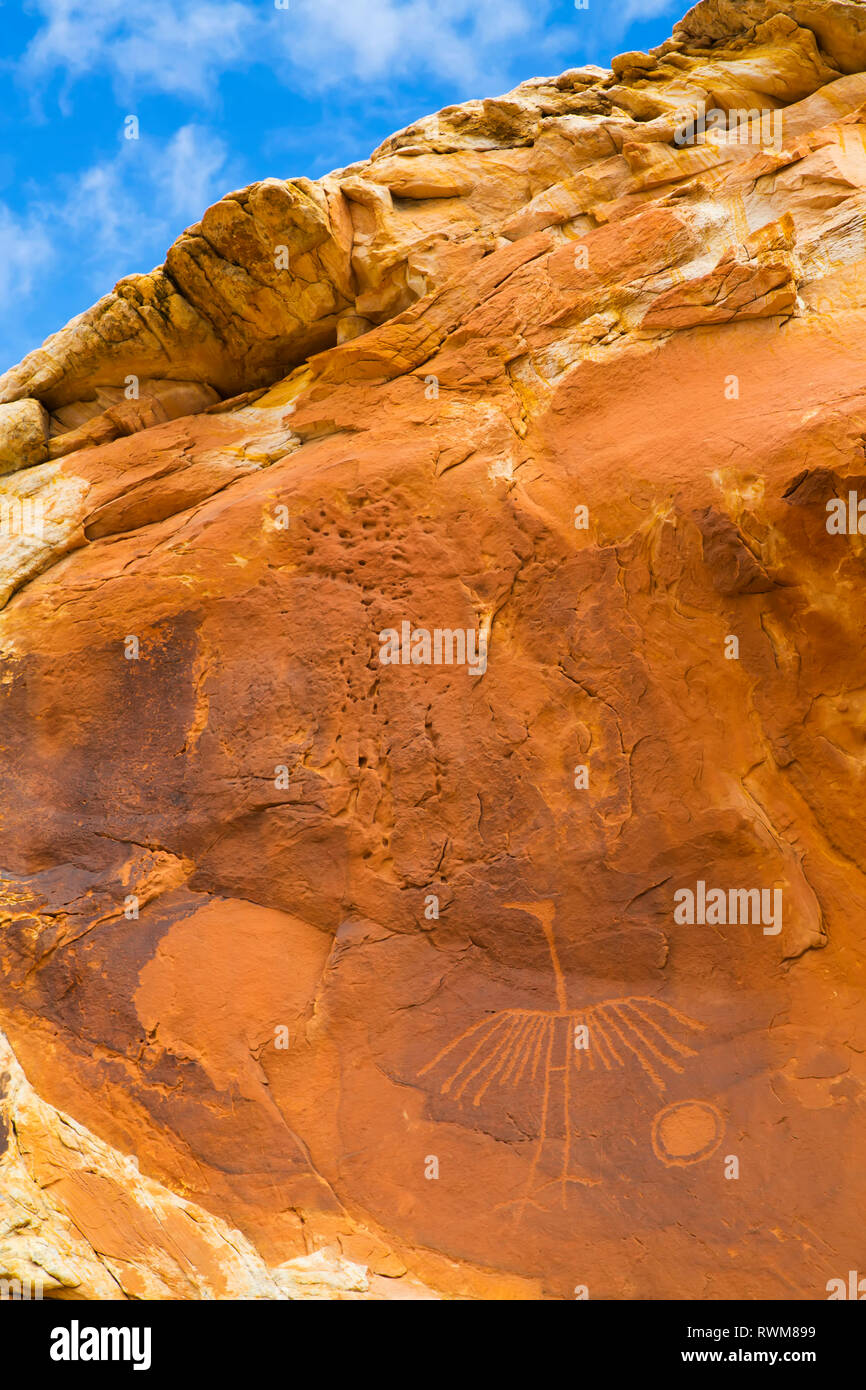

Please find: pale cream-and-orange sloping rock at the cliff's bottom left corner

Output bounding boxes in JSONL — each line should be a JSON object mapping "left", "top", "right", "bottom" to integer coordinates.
{"left": 0, "top": 1036, "right": 425, "bottom": 1300}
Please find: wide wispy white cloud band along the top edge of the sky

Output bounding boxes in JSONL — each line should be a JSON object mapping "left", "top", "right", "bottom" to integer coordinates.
{"left": 21, "top": 0, "right": 569, "bottom": 97}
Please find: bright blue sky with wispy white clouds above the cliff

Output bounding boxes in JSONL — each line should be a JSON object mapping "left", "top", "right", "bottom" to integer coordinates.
{"left": 0, "top": 0, "right": 687, "bottom": 371}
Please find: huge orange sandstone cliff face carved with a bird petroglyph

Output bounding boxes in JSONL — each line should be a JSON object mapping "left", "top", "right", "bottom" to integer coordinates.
{"left": 0, "top": 0, "right": 866, "bottom": 1300}
